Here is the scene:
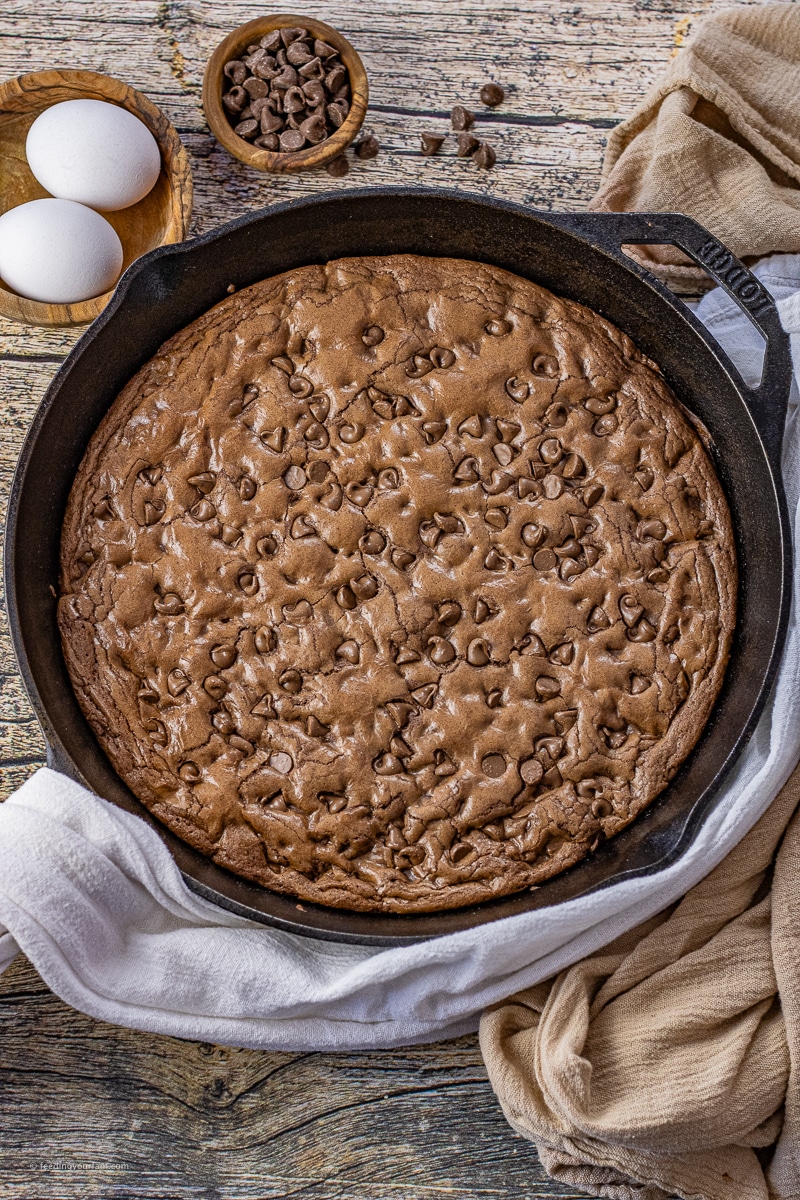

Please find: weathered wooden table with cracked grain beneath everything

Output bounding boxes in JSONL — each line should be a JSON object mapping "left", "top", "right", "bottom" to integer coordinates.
{"left": 0, "top": 0, "right": 754, "bottom": 1200}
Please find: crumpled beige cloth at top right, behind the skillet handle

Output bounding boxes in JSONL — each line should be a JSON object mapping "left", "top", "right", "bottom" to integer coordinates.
{"left": 589, "top": 4, "right": 800, "bottom": 287}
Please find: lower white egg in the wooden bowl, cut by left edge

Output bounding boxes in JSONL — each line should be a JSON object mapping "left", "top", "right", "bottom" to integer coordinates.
{"left": 0, "top": 199, "right": 122, "bottom": 304}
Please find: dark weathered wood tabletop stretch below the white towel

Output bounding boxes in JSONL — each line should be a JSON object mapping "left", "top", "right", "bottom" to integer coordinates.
{"left": 0, "top": 950, "right": 577, "bottom": 1200}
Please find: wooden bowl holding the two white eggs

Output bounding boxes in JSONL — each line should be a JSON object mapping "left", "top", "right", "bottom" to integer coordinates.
{"left": 0, "top": 71, "right": 192, "bottom": 325}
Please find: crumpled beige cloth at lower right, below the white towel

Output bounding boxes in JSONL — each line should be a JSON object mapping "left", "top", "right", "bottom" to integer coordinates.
{"left": 481, "top": 768, "right": 800, "bottom": 1200}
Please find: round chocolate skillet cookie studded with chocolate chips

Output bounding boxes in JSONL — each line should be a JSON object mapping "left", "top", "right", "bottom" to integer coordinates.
{"left": 59, "top": 256, "right": 736, "bottom": 912}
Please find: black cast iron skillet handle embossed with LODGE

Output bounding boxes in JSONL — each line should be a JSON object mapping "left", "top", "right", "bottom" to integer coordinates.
{"left": 548, "top": 212, "right": 793, "bottom": 472}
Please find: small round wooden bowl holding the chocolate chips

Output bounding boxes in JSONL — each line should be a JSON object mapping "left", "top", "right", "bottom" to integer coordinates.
{"left": 203, "top": 12, "right": 369, "bottom": 173}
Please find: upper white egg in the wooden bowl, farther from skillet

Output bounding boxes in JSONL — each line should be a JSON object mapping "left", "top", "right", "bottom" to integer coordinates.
{"left": 25, "top": 100, "right": 161, "bottom": 212}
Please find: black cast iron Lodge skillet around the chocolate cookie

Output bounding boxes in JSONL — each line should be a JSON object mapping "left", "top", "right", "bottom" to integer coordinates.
{"left": 6, "top": 188, "right": 790, "bottom": 944}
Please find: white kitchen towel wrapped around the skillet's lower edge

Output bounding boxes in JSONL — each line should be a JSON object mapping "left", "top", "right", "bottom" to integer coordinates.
{"left": 0, "top": 256, "right": 800, "bottom": 1050}
